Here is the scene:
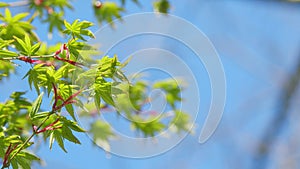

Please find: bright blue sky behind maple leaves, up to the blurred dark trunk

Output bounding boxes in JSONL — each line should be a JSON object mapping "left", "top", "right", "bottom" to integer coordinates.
{"left": 0, "top": 0, "right": 300, "bottom": 169}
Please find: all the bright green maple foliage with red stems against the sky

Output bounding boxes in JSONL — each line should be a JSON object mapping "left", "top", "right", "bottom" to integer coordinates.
{"left": 0, "top": 0, "right": 190, "bottom": 169}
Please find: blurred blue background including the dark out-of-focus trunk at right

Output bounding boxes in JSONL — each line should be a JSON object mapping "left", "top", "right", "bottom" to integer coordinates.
{"left": 0, "top": 0, "right": 300, "bottom": 169}
